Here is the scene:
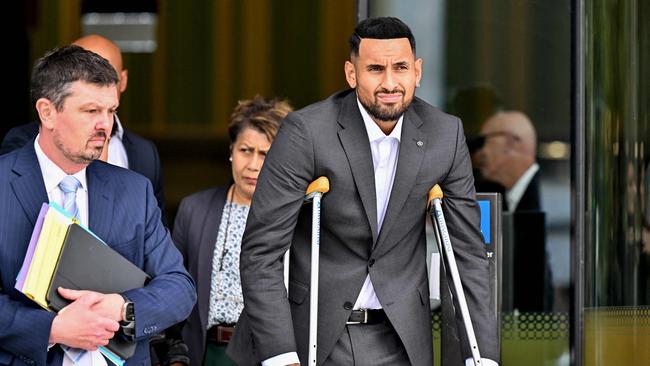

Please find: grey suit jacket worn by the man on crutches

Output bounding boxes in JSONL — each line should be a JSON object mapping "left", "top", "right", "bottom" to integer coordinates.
{"left": 228, "top": 90, "right": 499, "bottom": 366}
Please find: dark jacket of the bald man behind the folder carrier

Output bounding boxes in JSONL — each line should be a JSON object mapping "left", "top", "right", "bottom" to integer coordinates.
{"left": 0, "top": 122, "right": 167, "bottom": 225}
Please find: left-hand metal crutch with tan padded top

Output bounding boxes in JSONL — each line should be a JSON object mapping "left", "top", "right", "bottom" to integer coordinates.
{"left": 305, "top": 177, "right": 330, "bottom": 366}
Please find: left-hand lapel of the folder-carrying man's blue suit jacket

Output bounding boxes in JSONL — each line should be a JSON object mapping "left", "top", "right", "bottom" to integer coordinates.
{"left": 11, "top": 144, "right": 49, "bottom": 225}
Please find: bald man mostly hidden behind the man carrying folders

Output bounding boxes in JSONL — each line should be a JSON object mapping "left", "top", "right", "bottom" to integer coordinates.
{"left": 0, "top": 35, "right": 167, "bottom": 223}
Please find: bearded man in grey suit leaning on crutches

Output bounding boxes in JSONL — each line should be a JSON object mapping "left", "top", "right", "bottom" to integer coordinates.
{"left": 228, "top": 18, "right": 498, "bottom": 366}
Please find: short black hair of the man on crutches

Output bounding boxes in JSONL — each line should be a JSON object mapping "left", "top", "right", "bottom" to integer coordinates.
{"left": 350, "top": 17, "right": 415, "bottom": 56}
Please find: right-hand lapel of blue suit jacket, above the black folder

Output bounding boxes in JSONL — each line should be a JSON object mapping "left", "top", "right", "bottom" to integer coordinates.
{"left": 86, "top": 161, "right": 118, "bottom": 240}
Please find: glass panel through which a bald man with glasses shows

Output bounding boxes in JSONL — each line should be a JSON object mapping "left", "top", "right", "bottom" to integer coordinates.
{"left": 368, "top": 0, "right": 571, "bottom": 366}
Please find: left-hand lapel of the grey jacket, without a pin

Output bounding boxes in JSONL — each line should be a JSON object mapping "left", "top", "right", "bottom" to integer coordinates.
{"left": 338, "top": 92, "right": 378, "bottom": 245}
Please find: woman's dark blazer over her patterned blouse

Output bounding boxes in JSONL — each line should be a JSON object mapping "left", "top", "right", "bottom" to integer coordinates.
{"left": 173, "top": 185, "right": 229, "bottom": 365}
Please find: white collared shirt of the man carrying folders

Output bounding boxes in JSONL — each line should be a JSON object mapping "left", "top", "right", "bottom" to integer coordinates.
{"left": 34, "top": 134, "right": 107, "bottom": 366}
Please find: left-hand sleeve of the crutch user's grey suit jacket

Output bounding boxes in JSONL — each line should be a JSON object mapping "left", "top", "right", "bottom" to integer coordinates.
{"left": 240, "top": 113, "right": 314, "bottom": 360}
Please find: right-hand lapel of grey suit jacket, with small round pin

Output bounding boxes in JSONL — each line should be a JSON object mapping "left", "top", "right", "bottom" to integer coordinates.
{"left": 373, "top": 109, "right": 427, "bottom": 249}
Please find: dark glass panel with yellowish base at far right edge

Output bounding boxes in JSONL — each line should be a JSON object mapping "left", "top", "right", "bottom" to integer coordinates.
{"left": 584, "top": 0, "right": 650, "bottom": 365}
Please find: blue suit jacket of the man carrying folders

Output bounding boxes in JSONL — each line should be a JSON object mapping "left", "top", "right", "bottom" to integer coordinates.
{"left": 0, "top": 144, "right": 196, "bottom": 366}
